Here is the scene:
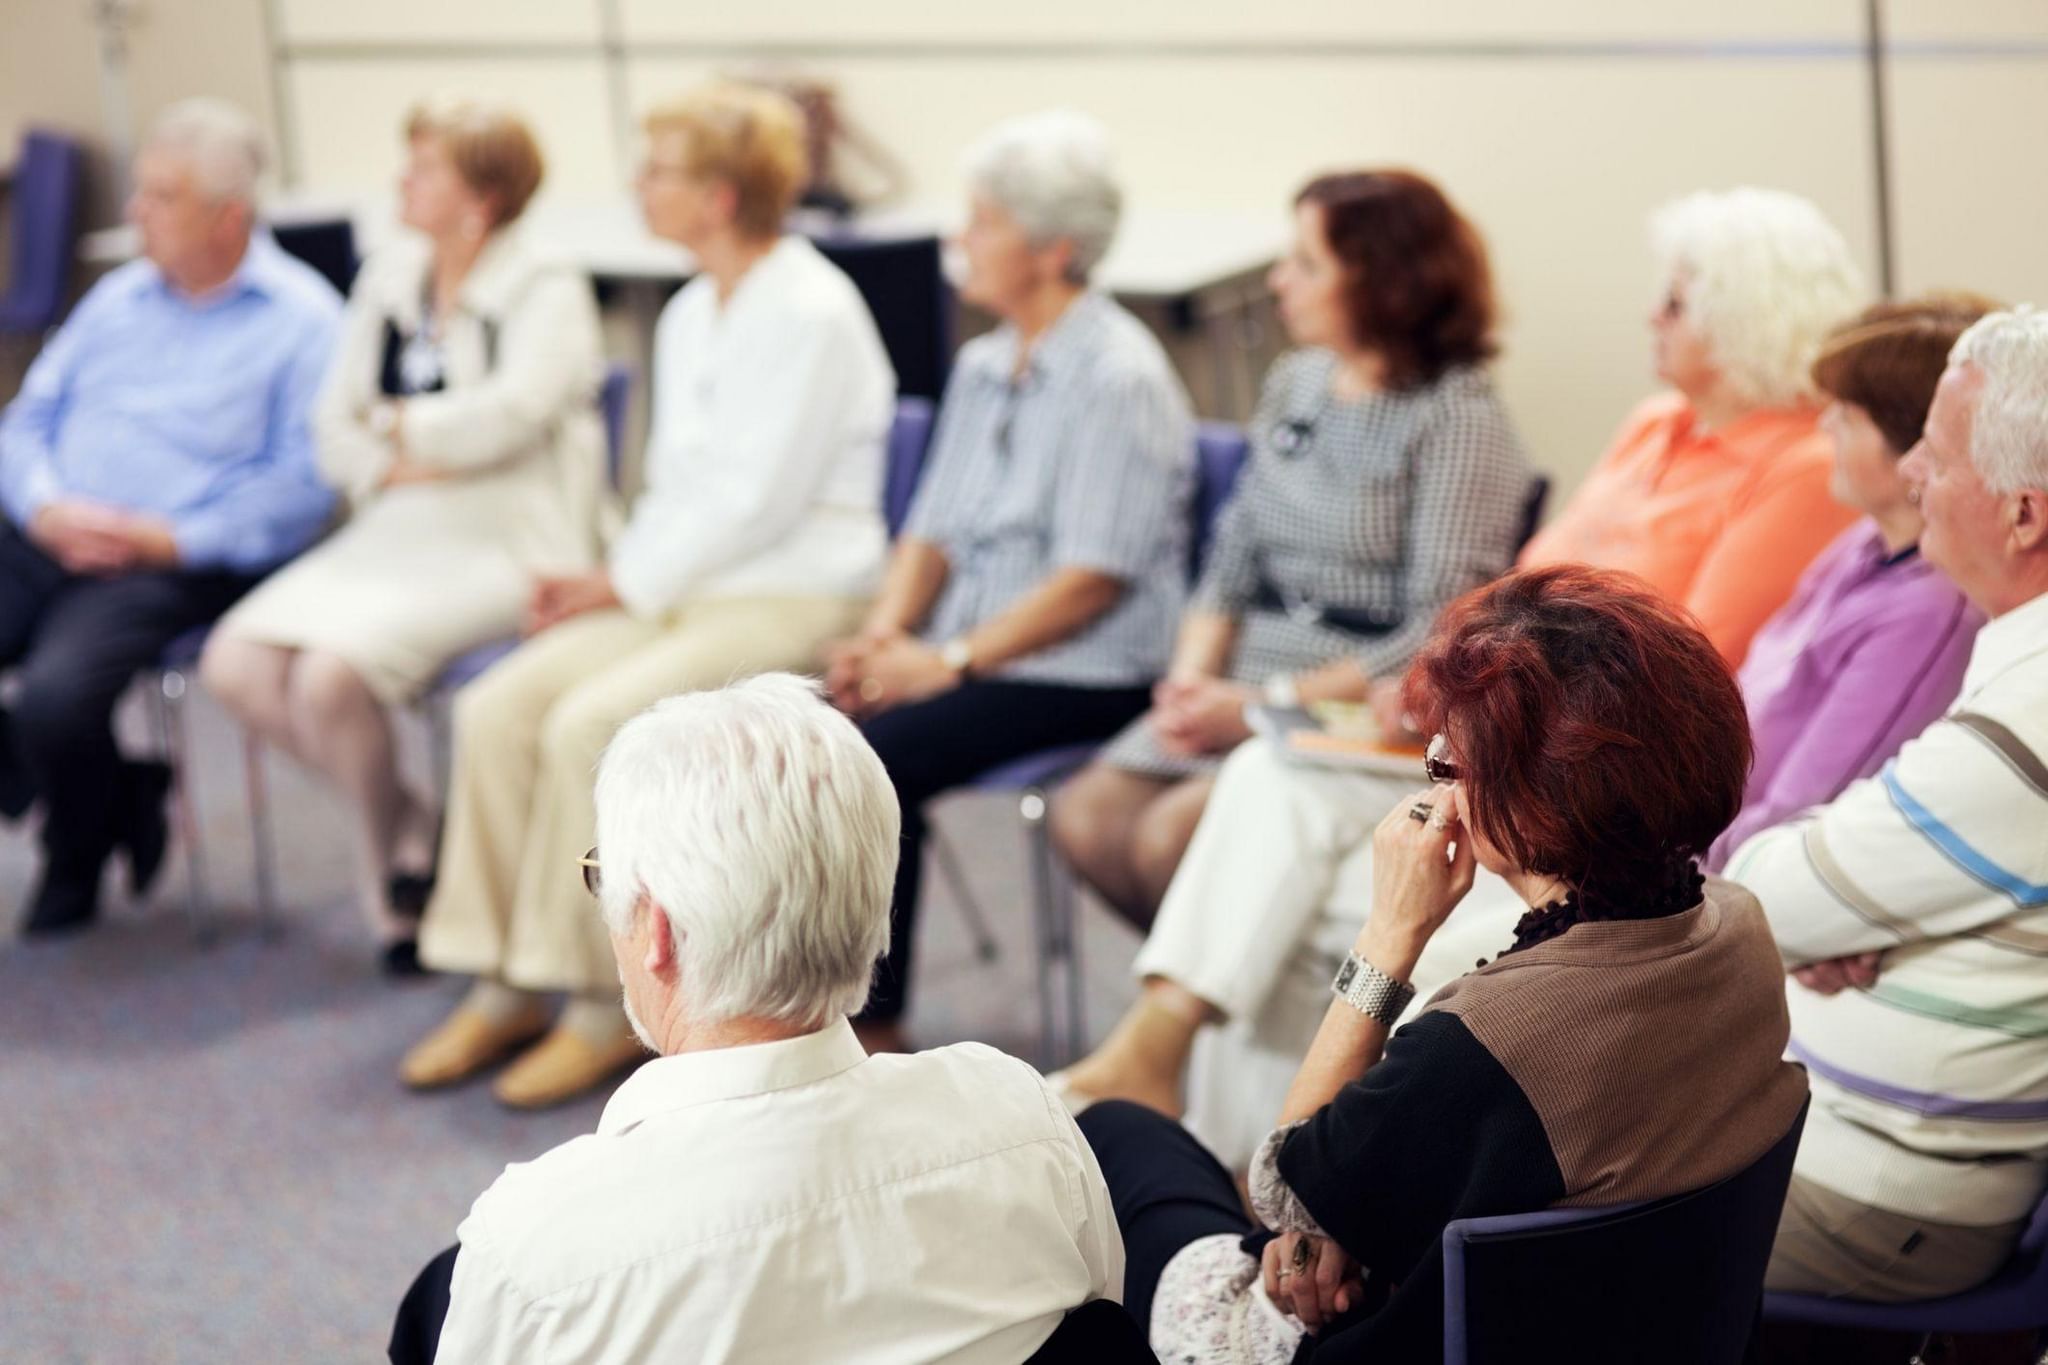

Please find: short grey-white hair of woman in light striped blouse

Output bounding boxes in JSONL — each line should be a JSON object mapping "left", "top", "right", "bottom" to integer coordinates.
{"left": 967, "top": 108, "right": 1124, "bottom": 284}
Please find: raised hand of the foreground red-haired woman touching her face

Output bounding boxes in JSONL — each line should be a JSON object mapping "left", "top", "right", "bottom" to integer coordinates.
{"left": 1360, "top": 784, "right": 1477, "bottom": 980}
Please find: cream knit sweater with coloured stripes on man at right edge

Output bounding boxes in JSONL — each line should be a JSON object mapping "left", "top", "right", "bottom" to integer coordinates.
{"left": 1726, "top": 596, "right": 2048, "bottom": 1226}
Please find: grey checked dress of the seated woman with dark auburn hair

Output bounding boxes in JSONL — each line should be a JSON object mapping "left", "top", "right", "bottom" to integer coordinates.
{"left": 1104, "top": 350, "right": 1534, "bottom": 778}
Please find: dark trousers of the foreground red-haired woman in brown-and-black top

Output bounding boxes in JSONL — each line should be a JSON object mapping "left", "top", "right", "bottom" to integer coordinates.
{"left": 1075, "top": 1099, "right": 1268, "bottom": 1332}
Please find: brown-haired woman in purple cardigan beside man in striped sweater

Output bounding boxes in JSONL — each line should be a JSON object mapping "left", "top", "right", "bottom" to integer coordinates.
{"left": 1704, "top": 295, "right": 1995, "bottom": 872}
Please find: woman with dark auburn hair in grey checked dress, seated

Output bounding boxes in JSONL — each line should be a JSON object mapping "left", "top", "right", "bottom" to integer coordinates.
{"left": 1053, "top": 170, "right": 1532, "bottom": 923}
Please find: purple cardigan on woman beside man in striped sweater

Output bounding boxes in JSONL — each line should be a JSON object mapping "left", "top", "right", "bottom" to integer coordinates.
{"left": 1706, "top": 520, "right": 1985, "bottom": 872}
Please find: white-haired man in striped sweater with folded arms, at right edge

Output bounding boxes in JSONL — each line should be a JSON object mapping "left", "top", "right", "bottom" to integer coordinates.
{"left": 1726, "top": 309, "right": 2048, "bottom": 1300}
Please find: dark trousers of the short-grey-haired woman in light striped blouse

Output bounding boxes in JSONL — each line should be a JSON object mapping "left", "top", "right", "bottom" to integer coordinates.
{"left": 862, "top": 681, "right": 1151, "bottom": 1021}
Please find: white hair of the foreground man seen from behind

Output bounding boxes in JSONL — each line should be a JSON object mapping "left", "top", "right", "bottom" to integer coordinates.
{"left": 598, "top": 673, "right": 903, "bottom": 1027}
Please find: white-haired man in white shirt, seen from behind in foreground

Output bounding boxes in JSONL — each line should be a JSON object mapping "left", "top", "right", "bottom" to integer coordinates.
{"left": 415, "top": 673, "right": 1122, "bottom": 1363}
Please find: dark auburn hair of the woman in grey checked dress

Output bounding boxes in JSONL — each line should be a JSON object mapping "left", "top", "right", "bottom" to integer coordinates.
{"left": 1294, "top": 170, "right": 1495, "bottom": 389}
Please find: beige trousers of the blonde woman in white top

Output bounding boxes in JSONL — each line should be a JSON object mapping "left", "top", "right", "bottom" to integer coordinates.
{"left": 420, "top": 598, "right": 866, "bottom": 995}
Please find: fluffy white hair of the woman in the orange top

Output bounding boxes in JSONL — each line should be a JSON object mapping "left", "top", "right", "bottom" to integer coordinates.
{"left": 1651, "top": 186, "right": 1866, "bottom": 407}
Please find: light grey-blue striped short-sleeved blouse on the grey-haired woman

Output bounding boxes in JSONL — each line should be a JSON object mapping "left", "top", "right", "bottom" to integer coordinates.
{"left": 903, "top": 293, "right": 1194, "bottom": 688}
